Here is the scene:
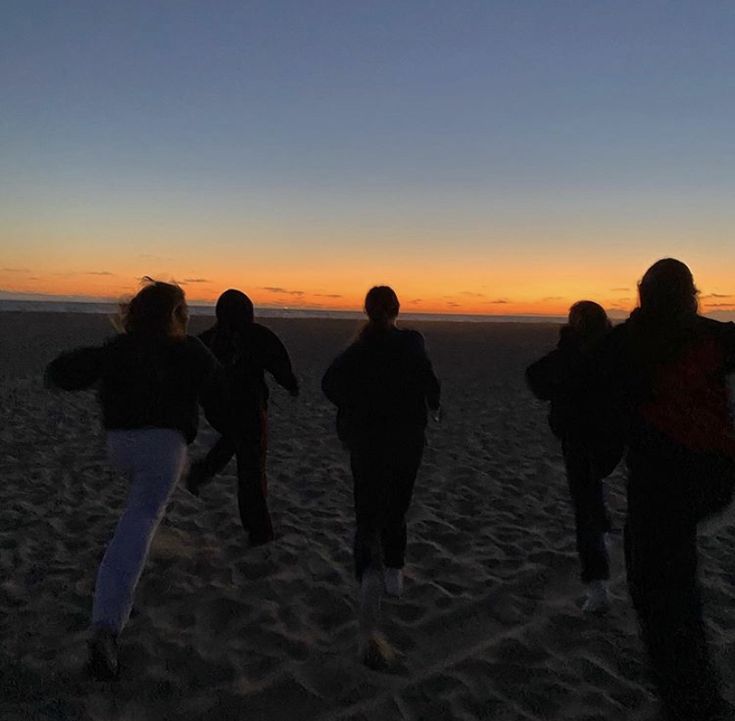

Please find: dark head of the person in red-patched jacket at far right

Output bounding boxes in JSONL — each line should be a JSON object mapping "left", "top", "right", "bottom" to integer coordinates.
{"left": 638, "top": 258, "right": 699, "bottom": 318}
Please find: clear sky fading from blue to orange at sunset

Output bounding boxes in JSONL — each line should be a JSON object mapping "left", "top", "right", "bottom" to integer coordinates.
{"left": 0, "top": 0, "right": 735, "bottom": 315}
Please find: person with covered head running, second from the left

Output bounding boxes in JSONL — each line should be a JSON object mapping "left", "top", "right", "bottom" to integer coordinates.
{"left": 186, "top": 289, "right": 299, "bottom": 546}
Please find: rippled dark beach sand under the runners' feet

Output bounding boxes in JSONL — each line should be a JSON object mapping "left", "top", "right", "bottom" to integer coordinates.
{"left": 0, "top": 313, "right": 735, "bottom": 721}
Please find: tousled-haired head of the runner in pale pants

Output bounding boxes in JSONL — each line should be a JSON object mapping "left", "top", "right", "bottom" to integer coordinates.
{"left": 120, "top": 276, "right": 189, "bottom": 337}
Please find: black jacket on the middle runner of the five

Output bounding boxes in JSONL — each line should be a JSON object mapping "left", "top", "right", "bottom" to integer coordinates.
{"left": 322, "top": 328, "right": 440, "bottom": 444}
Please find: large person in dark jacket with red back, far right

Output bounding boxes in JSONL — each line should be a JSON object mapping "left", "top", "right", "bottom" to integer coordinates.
{"left": 596, "top": 258, "right": 735, "bottom": 721}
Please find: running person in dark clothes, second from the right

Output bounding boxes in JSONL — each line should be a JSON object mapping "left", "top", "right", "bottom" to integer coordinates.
{"left": 526, "top": 300, "right": 623, "bottom": 613}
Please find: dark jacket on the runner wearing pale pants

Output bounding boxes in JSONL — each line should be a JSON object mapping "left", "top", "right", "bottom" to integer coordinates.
{"left": 46, "top": 333, "right": 221, "bottom": 443}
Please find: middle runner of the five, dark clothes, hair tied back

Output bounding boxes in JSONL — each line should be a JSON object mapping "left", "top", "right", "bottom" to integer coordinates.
{"left": 322, "top": 286, "right": 440, "bottom": 666}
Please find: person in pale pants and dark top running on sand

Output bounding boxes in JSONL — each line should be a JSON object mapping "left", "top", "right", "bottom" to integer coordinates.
{"left": 46, "top": 279, "right": 220, "bottom": 678}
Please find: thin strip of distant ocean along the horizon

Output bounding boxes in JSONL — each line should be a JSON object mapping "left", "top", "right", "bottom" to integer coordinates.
{"left": 0, "top": 299, "right": 565, "bottom": 323}
